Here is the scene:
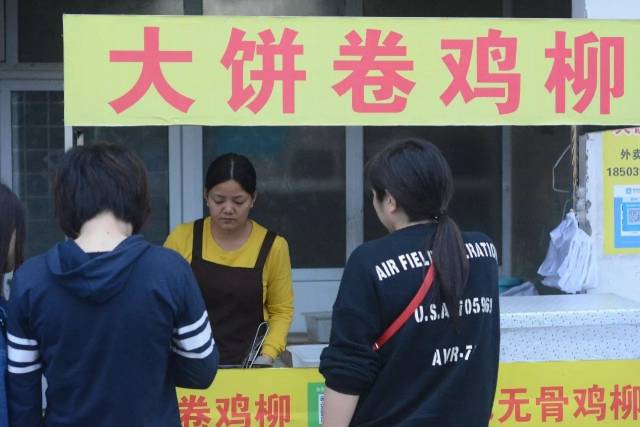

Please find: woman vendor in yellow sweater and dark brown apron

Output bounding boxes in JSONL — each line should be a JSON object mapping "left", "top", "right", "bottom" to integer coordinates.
{"left": 164, "top": 153, "right": 293, "bottom": 365}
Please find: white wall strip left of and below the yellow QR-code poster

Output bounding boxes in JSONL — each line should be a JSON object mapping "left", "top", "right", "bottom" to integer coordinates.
{"left": 580, "top": 132, "right": 640, "bottom": 301}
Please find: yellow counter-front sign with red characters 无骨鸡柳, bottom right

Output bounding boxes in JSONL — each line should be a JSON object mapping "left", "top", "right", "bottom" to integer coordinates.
{"left": 489, "top": 360, "right": 640, "bottom": 427}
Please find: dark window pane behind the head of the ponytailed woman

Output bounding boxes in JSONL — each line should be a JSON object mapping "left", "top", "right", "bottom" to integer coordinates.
{"left": 364, "top": 126, "right": 502, "bottom": 251}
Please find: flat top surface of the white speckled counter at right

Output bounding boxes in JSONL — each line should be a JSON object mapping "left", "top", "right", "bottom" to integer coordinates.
{"left": 500, "top": 294, "right": 640, "bottom": 329}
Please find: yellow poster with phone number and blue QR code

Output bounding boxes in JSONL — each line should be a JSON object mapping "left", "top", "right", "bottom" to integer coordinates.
{"left": 602, "top": 128, "right": 640, "bottom": 254}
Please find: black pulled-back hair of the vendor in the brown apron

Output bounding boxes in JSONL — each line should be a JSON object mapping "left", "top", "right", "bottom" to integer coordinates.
{"left": 204, "top": 153, "right": 256, "bottom": 195}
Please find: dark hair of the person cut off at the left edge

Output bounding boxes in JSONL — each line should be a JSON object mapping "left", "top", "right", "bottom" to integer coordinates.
{"left": 0, "top": 184, "right": 26, "bottom": 286}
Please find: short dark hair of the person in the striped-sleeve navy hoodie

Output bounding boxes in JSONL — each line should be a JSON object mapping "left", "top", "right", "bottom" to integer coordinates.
{"left": 54, "top": 143, "right": 151, "bottom": 239}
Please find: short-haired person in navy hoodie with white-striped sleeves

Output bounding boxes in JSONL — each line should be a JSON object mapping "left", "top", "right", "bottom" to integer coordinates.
{"left": 8, "top": 144, "right": 218, "bottom": 427}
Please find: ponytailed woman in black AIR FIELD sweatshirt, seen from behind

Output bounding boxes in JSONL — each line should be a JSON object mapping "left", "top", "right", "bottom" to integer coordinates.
{"left": 320, "top": 139, "right": 500, "bottom": 427}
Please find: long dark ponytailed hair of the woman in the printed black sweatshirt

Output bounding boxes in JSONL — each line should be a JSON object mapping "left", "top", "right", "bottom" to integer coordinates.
{"left": 366, "top": 138, "right": 469, "bottom": 326}
